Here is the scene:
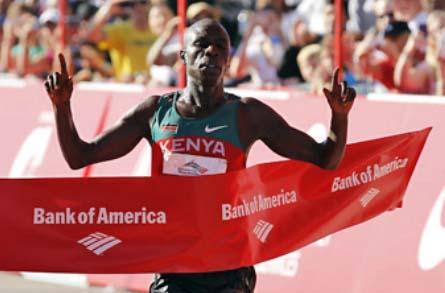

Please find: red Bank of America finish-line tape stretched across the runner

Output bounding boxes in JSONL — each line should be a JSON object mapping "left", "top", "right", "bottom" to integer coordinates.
{"left": 0, "top": 129, "right": 430, "bottom": 273}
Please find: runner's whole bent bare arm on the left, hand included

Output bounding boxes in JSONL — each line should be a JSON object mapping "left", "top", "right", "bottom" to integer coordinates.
{"left": 45, "top": 54, "right": 158, "bottom": 169}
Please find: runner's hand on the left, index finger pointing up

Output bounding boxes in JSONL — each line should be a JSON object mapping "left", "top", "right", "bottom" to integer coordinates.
{"left": 45, "top": 54, "right": 73, "bottom": 106}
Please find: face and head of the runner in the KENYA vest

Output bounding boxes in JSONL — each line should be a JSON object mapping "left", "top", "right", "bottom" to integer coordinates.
{"left": 183, "top": 23, "right": 230, "bottom": 85}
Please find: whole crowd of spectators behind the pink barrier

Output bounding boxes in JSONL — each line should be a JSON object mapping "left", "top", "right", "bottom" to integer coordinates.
{"left": 0, "top": 0, "right": 445, "bottom": 95}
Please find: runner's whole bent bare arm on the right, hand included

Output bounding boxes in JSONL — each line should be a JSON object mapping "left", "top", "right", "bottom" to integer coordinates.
{"left": 240, "top": 69, "right": 356, "bottom": 169}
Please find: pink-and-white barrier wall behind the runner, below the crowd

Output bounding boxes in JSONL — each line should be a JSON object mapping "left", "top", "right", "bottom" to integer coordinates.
{"left": 0, "top": 81, "right": 445, "bottom": 293}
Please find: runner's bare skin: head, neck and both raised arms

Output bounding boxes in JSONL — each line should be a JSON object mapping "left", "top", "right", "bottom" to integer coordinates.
{"left": 45, "top": 19, "right": 356, "bottom": 169}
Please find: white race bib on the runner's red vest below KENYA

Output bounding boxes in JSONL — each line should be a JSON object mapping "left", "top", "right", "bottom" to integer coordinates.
{"left": 162, "top": 153, "right": 227, "bottom": 176}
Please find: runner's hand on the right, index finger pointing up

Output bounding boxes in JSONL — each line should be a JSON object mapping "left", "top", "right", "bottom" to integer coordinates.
{"left": 323, "top": 68, "right": 356, "bottom": 115}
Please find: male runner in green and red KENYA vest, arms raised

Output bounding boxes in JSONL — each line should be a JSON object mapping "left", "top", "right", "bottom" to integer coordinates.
{"left": 45, "top": 19, "right": 356, "bottom": 293}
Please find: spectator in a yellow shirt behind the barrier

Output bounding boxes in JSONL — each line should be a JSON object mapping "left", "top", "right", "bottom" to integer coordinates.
{"left": 88, "top": 0, "right": 156, "bottom": 81}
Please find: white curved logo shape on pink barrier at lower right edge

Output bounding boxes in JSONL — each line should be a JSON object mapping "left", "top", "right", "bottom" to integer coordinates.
{"left": 418, "top": 187, "right": 445, "bottom": 271}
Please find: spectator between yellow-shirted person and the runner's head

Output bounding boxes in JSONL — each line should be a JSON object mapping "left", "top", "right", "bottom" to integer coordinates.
{"left": 147, "top": 3, "right": 180, "bottom": 86}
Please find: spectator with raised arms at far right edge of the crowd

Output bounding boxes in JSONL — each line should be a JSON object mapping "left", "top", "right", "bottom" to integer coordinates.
{"left": 394, "top": 11, "right": 445, "bottom": 94}
